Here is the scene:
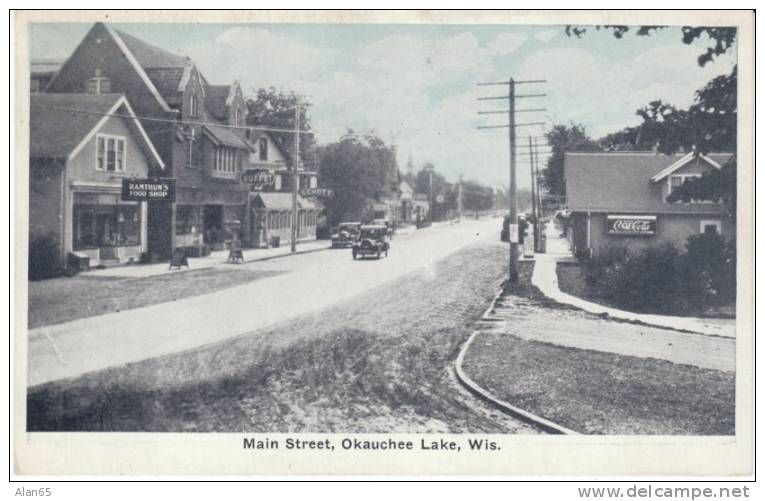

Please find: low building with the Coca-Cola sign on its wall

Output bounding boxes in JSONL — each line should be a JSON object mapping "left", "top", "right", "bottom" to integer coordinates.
{"left": 564, "top": 152, "right": 735, "bottom": 255}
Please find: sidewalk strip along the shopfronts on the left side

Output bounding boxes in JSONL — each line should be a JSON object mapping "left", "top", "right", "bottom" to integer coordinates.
{"left": 85, "top": 240, "right": 331, "bottom": 278}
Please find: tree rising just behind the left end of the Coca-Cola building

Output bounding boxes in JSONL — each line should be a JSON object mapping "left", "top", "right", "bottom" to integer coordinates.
{"left": 541, "top": 122, "right": 600, "bottom": 196}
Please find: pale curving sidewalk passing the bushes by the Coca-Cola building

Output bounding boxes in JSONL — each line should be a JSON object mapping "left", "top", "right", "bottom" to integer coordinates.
{"left": 531, "top": 221, "right": 736, "bottom": 338}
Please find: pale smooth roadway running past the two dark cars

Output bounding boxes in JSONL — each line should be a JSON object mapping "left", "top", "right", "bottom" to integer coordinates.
{"left": 28, "top": 219, "right": 500, "bottom": 386}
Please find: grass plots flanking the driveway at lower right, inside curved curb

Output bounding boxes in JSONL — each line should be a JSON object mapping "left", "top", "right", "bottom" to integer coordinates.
{"left": 463, "top": 258, "right": 736, "bottom": 435}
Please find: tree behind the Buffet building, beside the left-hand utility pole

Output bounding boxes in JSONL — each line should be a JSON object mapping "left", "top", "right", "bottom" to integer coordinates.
{"left": 247, "top": 87, "right": 316, "bottom": 166}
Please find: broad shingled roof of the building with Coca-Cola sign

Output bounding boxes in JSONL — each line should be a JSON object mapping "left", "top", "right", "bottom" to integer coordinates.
{"left": 564, "top": 152, "right": 731, "bottom": 213}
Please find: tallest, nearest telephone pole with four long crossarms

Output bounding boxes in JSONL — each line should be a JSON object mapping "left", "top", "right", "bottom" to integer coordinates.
{"left": 478, "top": 78, "right": 547, "bottom": 283}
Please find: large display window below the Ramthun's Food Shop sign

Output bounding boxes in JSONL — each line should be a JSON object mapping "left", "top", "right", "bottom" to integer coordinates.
{"left": 73, "top": 201, "right": 141, "bottom": 246}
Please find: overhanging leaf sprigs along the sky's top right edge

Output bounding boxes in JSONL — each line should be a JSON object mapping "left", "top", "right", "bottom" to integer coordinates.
{"left": 566, "top": 25, "right": 736, "bottom": 66}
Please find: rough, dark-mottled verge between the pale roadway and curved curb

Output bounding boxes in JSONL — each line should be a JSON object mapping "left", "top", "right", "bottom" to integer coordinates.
{"left": 27, "top": 242, "right": 536, "bottom": 433}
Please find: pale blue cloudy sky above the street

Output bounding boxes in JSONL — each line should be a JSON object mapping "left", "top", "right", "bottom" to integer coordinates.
{"left": 30, "top": 23, "right": 736, "bottom": 187}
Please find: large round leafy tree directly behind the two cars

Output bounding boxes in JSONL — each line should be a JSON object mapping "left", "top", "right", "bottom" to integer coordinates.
{"left": 317, "top": 134, "right": 395, "bottom": 226}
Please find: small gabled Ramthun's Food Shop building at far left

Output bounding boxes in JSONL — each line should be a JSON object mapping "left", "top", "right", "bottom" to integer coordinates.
{"left": 29, "top": 94, "right": 164, "bottom": 268}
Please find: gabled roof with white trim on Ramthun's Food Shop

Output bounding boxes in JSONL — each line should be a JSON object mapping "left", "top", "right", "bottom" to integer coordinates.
{"left": 29, "top": 94, "right": 165, "bottom": 168}
